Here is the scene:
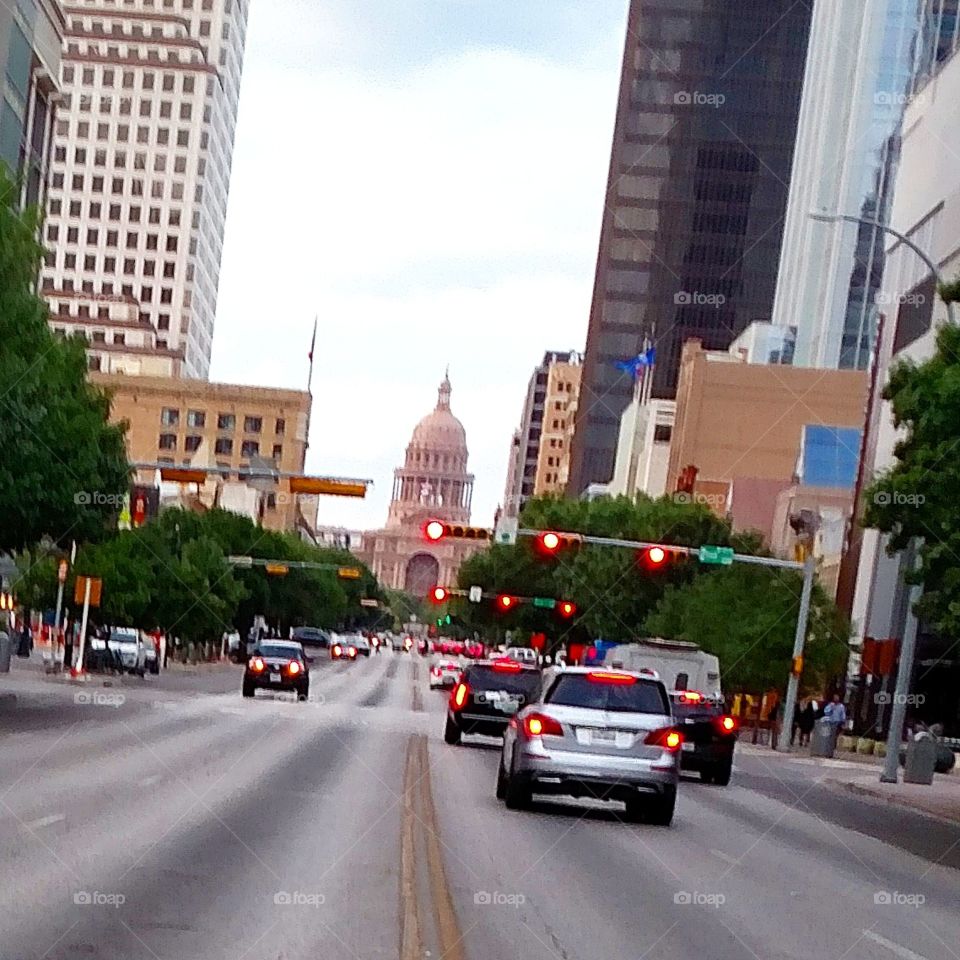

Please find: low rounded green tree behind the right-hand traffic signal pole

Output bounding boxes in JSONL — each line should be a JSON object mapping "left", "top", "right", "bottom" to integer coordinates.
{"left": 645, "top": 564, "right": 850, "bottom": 694}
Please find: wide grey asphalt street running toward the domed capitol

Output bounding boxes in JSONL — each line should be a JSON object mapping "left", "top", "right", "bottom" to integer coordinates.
{"left": 0, "top": 654, "right": 960, "bottom": 960}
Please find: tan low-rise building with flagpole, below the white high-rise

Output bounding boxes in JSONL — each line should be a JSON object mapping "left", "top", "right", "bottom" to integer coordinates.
{"left": 90, "top": 371, "right": 317, "bottom": 530}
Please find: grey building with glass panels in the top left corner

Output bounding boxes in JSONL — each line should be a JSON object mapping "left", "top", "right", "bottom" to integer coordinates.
{"left": 0, "top": 0, "right": 66, "bottom": 206}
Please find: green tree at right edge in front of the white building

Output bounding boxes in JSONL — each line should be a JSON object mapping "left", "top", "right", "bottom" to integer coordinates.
{"left": 865, "top": 322, "right": 960, "bottom": 636}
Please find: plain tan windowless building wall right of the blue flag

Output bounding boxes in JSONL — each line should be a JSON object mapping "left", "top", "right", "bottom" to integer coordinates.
{"left": 666, "top": 340, "right": 867, "bottom": 493}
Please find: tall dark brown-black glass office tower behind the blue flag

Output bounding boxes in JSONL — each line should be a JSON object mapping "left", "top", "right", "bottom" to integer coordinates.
{"left": 568, "top": 0, "right": 812, "bottom": 495}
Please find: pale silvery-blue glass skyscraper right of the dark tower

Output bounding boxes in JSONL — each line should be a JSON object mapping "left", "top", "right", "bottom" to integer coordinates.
{"left": 772, "top": 0, "right": 928, "bottom": 369}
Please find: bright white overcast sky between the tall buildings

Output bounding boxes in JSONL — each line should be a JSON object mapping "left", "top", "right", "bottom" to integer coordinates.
{"left": 211, "top": 0, "right": 628, "bottom": 528}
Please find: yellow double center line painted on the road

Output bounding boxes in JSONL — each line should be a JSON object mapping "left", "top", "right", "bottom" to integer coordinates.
{"left": 400, "top": 734, "right": 466, "bottom": 960}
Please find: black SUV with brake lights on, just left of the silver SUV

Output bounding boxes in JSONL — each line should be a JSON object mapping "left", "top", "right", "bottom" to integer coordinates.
{"left": 443, "top": 660, "right": 540, "bottom": 744}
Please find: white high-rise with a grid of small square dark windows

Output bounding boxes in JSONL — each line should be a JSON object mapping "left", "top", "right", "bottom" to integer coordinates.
{"left": 43, "top": 0, "right": 250, "bottom": 378}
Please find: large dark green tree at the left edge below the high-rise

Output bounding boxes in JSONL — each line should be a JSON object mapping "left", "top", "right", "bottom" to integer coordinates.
{"left": 0, "top": 172, "right": 129, "bottom": 550}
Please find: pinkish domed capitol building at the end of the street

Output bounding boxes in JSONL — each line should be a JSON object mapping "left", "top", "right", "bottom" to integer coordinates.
{"left": 360, "top": 375, "right": 483, "bottom": 597}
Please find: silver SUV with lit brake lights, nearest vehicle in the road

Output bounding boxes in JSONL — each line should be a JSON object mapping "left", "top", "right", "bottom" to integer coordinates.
{"left": 497, "top": 667, "right": 683, "bottom": 826}
